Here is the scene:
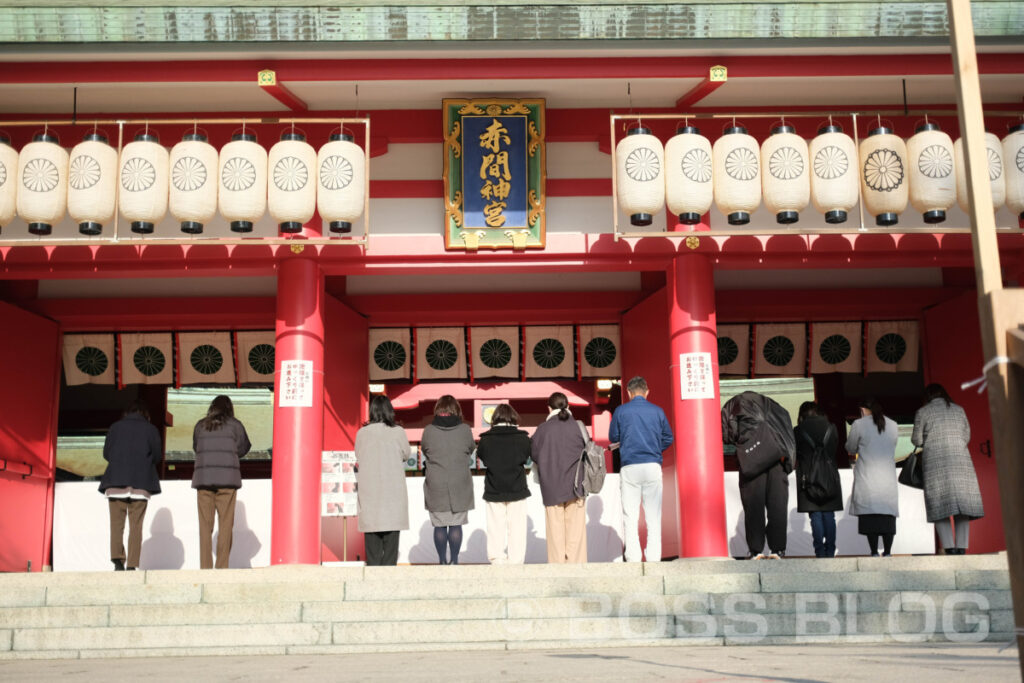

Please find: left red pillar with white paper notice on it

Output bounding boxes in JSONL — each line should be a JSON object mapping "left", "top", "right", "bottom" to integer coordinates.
{"left": 270, "top": 258, "right": 325, "bottom": 564}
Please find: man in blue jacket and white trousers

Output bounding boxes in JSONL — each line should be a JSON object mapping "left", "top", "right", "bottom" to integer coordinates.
{"left": 608, "top": 376, "right": 673, "bottom": 562}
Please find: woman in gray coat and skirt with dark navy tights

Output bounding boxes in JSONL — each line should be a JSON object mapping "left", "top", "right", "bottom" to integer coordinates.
{"left": 420, "top": 394, "right": 476, "bottom": 564}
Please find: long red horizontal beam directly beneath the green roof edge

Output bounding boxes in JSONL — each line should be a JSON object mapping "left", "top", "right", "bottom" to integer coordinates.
{"left": 0, "top": 53, "right": 1024, "bottom": 83}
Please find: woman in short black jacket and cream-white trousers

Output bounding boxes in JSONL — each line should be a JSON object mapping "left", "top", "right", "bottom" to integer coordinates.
{"left": 476, "top": 403, "right": 529, "bottom": 564}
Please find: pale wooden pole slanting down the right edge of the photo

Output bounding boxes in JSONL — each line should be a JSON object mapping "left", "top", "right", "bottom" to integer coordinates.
{"left": 946, "top": 0, "right": 1024, "bottom": 663}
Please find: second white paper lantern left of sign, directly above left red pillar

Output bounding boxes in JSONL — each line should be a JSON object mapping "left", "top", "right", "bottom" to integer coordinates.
{"left": 266, "top": 131, "right": 316, "bottom": 232}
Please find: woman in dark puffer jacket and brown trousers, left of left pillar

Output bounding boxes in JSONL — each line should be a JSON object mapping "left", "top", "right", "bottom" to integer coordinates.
{"left": 193, "top": 395, "right": 252, "bottom": 569}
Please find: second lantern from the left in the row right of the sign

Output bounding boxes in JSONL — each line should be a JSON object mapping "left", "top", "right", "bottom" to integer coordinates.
{"left": 665, "top": 126, "right": 715, "bottom": 225}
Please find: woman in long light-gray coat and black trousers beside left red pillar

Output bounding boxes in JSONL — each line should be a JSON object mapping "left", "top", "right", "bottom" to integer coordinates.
{"left": 355, "top": 395, "right": 409, "bottom": 566}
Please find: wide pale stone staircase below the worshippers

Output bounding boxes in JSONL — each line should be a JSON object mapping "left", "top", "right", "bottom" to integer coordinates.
{"left": 0, "top": 554, "right": 1014, "bottom": 659}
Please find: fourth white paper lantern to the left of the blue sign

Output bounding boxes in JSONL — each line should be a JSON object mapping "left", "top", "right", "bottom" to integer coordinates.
{"left": 168, "top": 131, "right": 219, "bottom": 234}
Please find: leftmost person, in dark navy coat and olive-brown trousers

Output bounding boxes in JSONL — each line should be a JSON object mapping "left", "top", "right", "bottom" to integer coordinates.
{"left": 99, "top": 400, "right": 164, "bottom": 571}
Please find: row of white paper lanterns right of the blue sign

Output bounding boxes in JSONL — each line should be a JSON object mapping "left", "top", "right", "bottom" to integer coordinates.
{"left": 615, "top": 122, "right": 1024, "bottom": 226}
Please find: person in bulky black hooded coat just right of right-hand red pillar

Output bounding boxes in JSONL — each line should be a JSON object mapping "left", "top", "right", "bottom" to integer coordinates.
{"left": 722, "top": 391, "right": 796, "bottom": 559}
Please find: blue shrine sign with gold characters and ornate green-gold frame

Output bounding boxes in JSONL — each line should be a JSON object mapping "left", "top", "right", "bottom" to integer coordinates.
{"left": 443, "top": 99, "right": 546, "bottom": 250}
